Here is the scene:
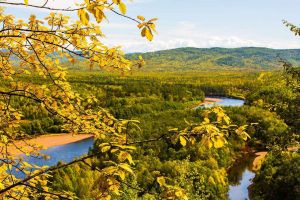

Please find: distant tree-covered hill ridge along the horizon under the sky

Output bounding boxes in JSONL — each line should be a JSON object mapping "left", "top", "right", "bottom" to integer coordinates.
{"left": 126, "top": 47, "right": 300, "bottom": 71}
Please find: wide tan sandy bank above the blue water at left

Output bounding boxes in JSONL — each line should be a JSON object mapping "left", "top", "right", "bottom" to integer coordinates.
{"left": 8, "top": 134, "right": 93, "bottom": 156}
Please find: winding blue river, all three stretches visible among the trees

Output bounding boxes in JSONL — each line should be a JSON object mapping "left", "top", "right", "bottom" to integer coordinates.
{"left": 19, "top": 97, "right": 255, "bottom": 200}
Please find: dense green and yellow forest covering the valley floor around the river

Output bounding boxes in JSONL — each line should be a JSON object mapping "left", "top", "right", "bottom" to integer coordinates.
{"left": 9, "top": 63, "right": 299, "bottom": 199}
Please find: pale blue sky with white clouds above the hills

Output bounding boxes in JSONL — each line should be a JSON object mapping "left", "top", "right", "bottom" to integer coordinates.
{"left": 6, "top": 0, "right": 300, "bottom": 53}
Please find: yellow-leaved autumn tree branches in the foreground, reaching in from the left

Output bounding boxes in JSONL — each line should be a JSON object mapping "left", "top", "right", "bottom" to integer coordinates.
{"left": 0, "top": 0, "right": 247, "bottom": 199}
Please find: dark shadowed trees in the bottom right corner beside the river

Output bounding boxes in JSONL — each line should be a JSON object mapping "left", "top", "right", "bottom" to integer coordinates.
{"left": 252, "top": 151, "right": 300, "bottom": 200}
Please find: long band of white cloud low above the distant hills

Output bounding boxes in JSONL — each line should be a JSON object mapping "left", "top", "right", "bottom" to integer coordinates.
{"left": 100, "top": 22, "right": 299, "bottom": 53}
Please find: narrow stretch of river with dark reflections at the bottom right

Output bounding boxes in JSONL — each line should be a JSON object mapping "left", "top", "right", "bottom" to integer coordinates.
{"left": 228, "top": 155, "right": 255, "bottom": 200}
